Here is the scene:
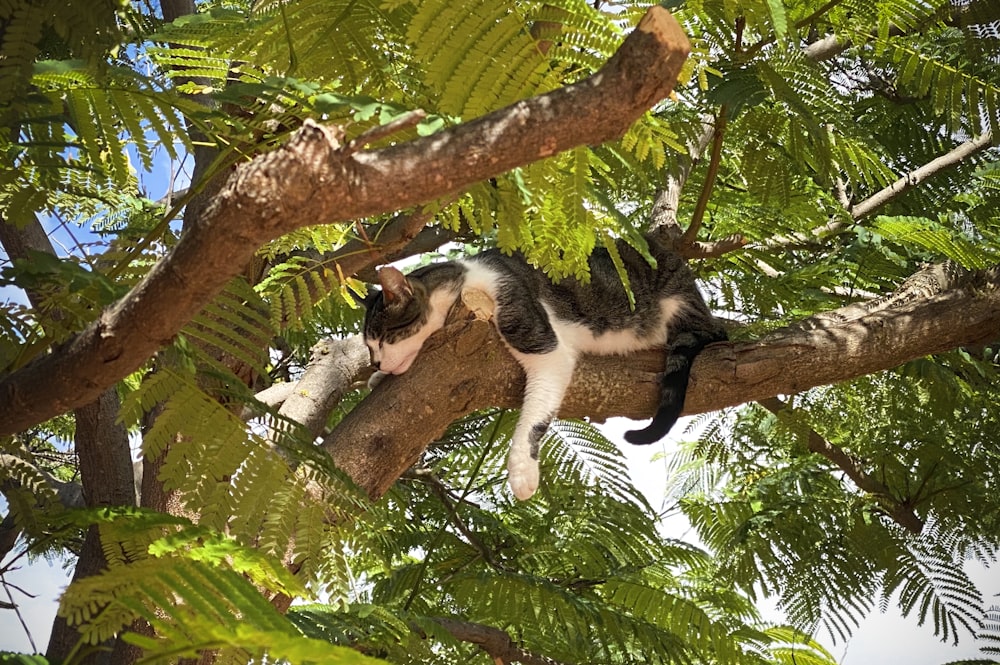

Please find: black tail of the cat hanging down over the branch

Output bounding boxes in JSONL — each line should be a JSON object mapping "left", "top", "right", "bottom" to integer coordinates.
{"left": 625, "top": 332, "right": 725, "bottom": 445}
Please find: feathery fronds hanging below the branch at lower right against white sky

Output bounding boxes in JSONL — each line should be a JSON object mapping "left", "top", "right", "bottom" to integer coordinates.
{"left": 674, "top": 368, "right": 997, "bottom": 640}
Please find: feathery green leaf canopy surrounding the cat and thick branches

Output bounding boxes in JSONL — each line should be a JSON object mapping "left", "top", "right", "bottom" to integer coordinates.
{"left": 0, "top": 0, "right": 1000, "bottom": 665}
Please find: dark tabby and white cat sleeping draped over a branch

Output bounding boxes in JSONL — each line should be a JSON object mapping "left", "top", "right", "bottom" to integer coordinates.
{"left": 364, "top": 234, "right": 726, "bottom": 500}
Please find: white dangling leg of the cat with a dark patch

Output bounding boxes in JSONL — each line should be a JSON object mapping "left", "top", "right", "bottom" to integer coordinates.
{"left": 507, "top": 346, "right": 576, "bottom": 501}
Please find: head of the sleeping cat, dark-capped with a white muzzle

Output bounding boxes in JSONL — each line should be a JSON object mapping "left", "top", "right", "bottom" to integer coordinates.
{"left": 364, "top": 266, "right": 432, "bottom": 374}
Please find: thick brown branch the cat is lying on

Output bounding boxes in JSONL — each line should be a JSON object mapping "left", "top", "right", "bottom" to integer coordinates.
{"left": 323, "top": 267, "right": 1000, "bottom": 497}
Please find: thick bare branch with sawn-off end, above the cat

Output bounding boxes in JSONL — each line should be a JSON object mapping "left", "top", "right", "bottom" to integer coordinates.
{"left": 0, "top": 6, "right": 690, "bottom": 436}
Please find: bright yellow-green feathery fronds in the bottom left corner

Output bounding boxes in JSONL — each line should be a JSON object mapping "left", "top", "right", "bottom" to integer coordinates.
{"left": 59, "top": 512, "right": 377, "bottom": 663}
